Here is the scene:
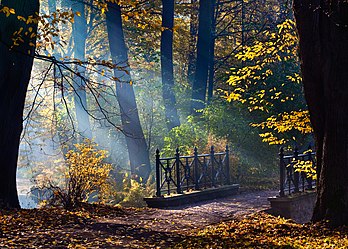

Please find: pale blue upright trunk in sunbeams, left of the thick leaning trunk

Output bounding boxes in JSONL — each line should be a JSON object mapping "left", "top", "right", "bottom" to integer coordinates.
{"left": 72, "top": 1, "right": 92, "bottom": 142}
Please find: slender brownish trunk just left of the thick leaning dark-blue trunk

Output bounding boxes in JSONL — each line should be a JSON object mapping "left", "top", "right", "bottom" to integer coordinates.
{"left": 187, "top": 0, "right": 198, "bottom": 86}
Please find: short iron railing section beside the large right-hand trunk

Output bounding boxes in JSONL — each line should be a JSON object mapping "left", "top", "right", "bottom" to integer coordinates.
{"left": 279, "top": 146, "right": 316, "bottom": 196}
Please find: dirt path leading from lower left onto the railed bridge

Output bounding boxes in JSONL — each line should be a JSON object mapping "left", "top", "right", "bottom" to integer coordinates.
{"left": 92, "top": 191, "right": 277, "bottom": 248}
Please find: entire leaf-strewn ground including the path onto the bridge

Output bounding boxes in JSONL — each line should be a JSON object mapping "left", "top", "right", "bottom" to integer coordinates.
{"left": 0, "top": 191, "right": 348, "bottom": 248}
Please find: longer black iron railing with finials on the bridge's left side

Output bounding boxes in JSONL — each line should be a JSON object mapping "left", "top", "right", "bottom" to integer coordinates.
{"left": 156, "top": 146, "right": 230, "bottom": 197}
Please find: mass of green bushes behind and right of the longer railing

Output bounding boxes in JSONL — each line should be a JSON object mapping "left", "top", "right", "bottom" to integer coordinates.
{"left": 161, "top": 100, "right": 278, "bottom": 185}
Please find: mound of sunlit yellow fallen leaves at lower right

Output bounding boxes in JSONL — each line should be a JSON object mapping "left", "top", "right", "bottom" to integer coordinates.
{"left": 175, "top": 213, "right": 348, "bottom": 249}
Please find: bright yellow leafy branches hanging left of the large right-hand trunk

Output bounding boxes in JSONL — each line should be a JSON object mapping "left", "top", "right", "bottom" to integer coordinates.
{"left": 224, "top": 20, "right": 312, "bottom": 147}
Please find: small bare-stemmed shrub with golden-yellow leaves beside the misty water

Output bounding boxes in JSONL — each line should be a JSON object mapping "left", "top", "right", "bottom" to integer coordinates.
{"left": 36, "top": 140, "right": 111, "bottom": 209}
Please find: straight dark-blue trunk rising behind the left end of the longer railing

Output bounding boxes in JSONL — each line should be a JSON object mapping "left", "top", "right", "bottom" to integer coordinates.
{"left": 161, "top": 0, "right": 180, "bottom": 131}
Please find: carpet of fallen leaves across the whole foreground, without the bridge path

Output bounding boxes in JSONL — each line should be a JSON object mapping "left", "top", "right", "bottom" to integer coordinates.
{"left": 0, "top": 209, "right": 348, "bottom": 249}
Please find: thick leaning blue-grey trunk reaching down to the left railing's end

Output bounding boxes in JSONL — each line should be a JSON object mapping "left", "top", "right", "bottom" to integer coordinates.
{"left": 106, "top": 2, "right": 151, "bottom": 180}
